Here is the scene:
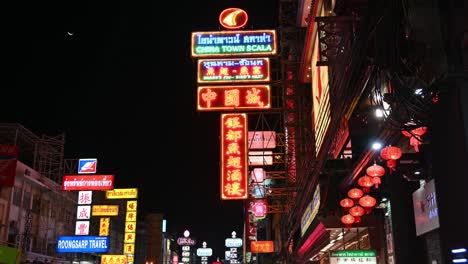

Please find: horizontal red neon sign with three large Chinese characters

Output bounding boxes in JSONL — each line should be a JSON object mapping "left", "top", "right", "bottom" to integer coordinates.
{"left": 197, "top": 85, "right": 271, "bottom": 111}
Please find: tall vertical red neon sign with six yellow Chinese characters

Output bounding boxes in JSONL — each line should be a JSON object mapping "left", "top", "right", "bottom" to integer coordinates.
{"left": 221, "top": 113, "right": 248, "bottom": 200}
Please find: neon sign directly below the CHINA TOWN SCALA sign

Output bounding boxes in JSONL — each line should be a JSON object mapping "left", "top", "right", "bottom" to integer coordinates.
{"left": 198, "top": 58, "right": 270, "bottom": 83}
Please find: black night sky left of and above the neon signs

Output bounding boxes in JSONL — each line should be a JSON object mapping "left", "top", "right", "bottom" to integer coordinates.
{"left": 4, "top": 0, "right": 278, "bottom": 256}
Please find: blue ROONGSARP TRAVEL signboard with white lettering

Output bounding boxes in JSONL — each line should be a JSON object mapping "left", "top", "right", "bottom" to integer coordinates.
{"left": 57, "top": 236, "right": 109, "bottom": 253}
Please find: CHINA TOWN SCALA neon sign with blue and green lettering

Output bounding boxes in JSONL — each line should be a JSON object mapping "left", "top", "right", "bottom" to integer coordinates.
{"left": 192, "top": 30, "right": 277, "bottom": 57}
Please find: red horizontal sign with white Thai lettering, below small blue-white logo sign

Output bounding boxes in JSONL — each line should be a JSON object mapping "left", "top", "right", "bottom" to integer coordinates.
{"left": 62, "top": 175, "right": 114, "bottom": 191}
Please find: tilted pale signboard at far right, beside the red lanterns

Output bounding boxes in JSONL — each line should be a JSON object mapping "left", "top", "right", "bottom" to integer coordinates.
{"left": 413, "top": 180, "right": 439, "bottom": 236}
